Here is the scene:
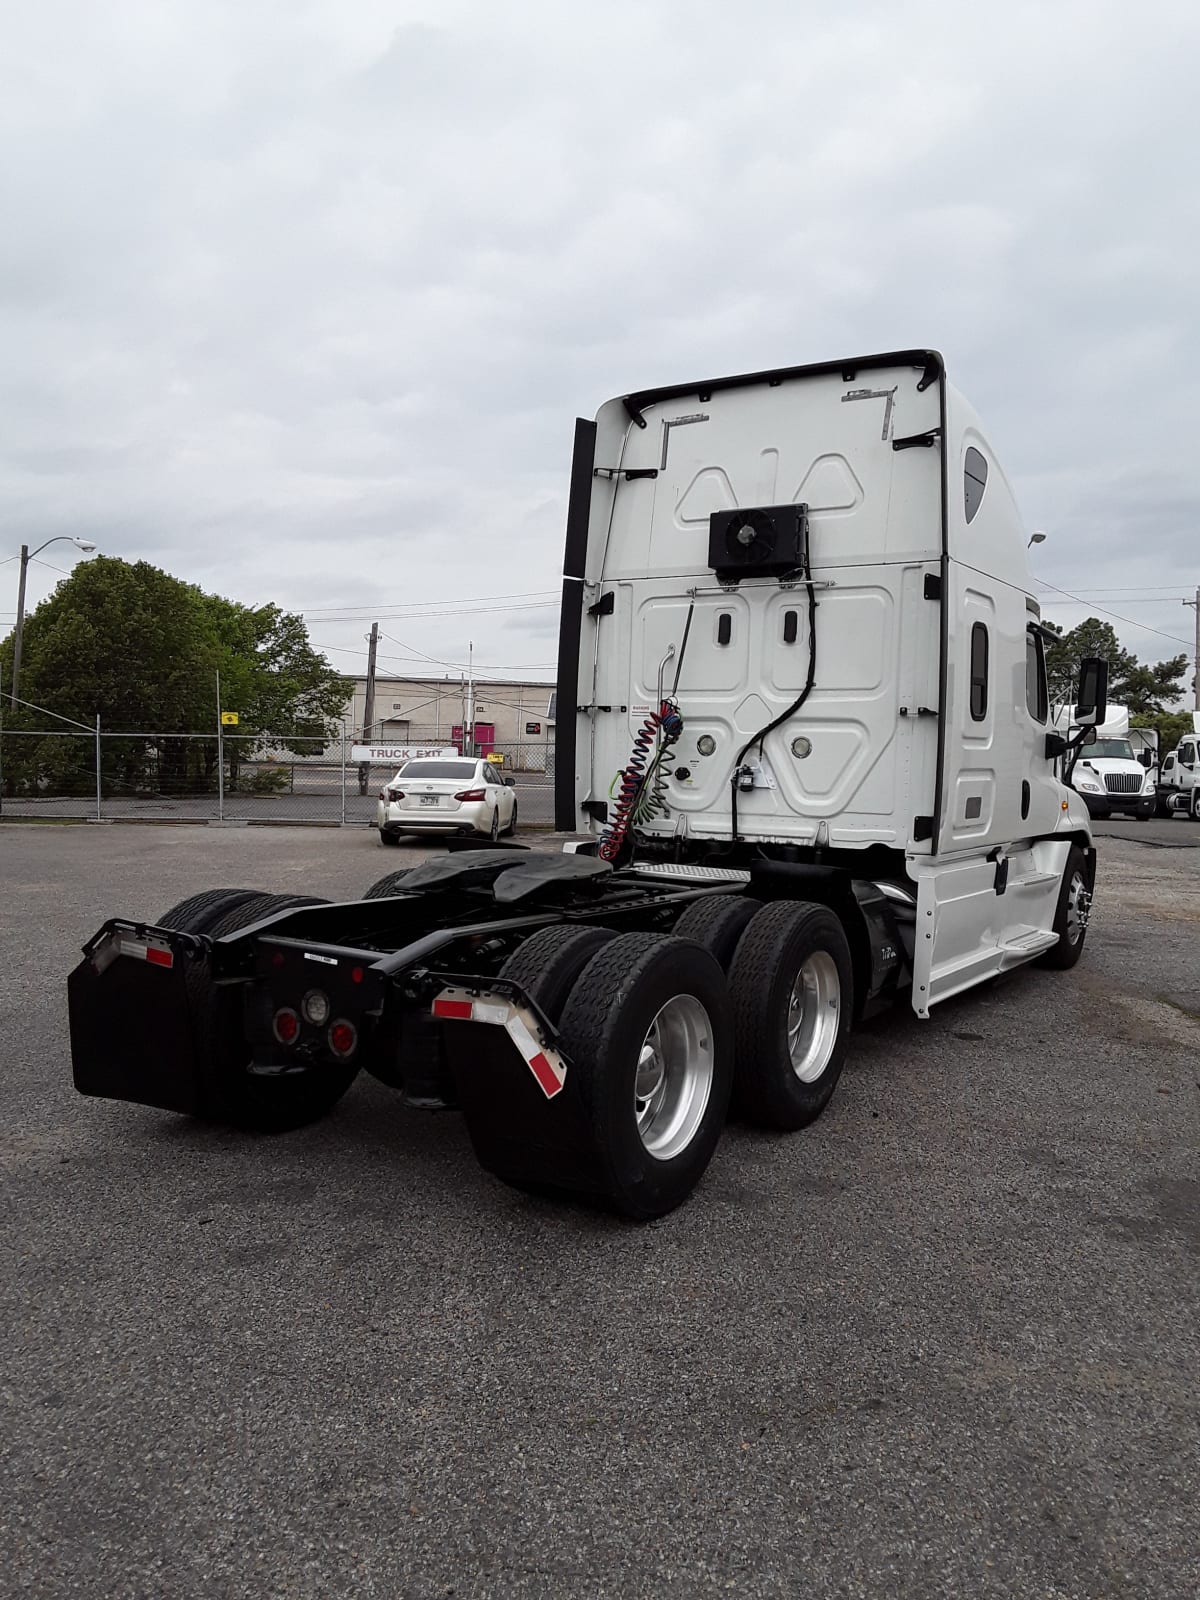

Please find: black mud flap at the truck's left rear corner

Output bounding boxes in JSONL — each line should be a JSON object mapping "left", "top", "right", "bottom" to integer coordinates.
{"left": 67, "top": 922, "right": 206, "bottom": 1115}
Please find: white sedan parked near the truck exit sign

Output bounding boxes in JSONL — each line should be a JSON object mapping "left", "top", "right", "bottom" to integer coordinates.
{"left": 374, "top": 755, "right": 517, "bottom": 845}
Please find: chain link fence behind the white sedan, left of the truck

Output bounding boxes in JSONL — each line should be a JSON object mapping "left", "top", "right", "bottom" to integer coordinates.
{"left": 0, "top": 714, "right": 554, "bottom": 827}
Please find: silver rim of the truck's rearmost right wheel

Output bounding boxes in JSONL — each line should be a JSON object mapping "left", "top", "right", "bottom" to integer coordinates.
{"left": 634, "top": 995, "right": 712, "bottom": 1162}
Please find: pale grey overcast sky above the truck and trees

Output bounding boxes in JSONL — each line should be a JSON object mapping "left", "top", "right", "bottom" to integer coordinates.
{"left": 0, "top": 0, "right": 1200, "bottom": 691}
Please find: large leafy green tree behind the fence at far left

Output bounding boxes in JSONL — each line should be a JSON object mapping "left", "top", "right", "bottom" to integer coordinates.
{"left": 0, "top": 557, "right": 347, "bottom": 794}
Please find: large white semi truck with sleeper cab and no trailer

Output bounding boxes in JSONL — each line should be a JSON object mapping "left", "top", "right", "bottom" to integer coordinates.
{"left": 69, "top": 350, "right": 1107, "bottom": 1218}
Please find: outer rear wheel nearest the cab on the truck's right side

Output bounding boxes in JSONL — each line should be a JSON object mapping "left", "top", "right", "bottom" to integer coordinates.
{"left": 730, "top": 901, "right": 854, "bottom": 1133}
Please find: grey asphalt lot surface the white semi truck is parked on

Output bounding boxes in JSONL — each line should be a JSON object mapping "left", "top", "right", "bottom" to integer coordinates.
{"left": 0, "top": 824, "right": 1200, "bottom": 1600}
